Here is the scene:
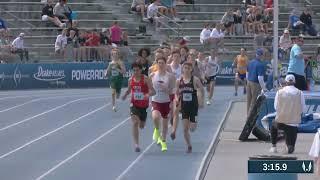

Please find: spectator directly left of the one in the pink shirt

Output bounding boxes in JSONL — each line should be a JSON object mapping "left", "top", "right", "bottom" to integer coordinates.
{"left": 100, "top": 28, "right": 111, "bottom": 60}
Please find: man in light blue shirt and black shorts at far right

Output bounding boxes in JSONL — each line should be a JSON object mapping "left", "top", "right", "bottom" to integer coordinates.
{"left": 287, "top": 36, "right": 307, "bottom": 91}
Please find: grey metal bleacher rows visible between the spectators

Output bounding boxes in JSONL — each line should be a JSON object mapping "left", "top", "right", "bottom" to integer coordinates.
{"left": 0, "top": 0, "right": 320, "bottom": 60}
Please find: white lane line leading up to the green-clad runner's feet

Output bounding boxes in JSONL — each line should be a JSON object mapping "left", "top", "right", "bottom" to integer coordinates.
{"left": 0, "top": 103, "right": 111, "bottom": 159}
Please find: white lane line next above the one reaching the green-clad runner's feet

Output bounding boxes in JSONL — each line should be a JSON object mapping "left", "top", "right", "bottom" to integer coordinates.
{"left": 0, "top": 97, "right": 106, "bottom": 132}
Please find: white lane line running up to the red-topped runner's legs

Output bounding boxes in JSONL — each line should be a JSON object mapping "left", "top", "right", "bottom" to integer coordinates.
{"left": 36, "top": 117, "right": 130, "bottom": 180}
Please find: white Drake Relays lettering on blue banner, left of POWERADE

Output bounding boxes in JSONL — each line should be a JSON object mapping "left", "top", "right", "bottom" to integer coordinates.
{"left": 33, "top": 66, "right": 66, "bottom": 81}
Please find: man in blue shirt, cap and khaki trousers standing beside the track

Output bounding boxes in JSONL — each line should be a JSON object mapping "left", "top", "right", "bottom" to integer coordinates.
{"left": 246, "top": 48, "right": 267, "bottom": 114}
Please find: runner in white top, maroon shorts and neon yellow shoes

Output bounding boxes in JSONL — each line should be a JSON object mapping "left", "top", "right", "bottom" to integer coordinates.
{"left": 150, "top": 57, "right": 175, "bottom": 152}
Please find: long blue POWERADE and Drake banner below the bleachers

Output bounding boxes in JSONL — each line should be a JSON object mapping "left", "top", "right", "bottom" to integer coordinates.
{"left": 0, "top": 61, "right": 286, "bottom": 90}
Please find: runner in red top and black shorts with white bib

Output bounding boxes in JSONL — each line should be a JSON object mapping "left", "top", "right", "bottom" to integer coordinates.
{"left": 122, "top": 63, "right": 155, "bottom": 152}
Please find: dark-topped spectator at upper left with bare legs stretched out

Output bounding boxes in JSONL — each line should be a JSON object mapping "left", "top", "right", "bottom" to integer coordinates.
{"left": 41, "top": 0, "right": 66, "bottom": 28}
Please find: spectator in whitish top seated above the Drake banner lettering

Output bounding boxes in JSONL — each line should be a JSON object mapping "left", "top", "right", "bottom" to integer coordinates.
{"left": 55, "top": 29, "right": 68, "bottom": 61}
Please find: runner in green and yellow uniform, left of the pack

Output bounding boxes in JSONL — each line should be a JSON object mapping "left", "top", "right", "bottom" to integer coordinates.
{"left": 106, "top": 48, "right": 126, "bottom": 112}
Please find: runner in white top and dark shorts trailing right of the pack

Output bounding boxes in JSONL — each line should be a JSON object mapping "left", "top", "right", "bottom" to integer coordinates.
{"left": 205, "top": 50, "right": 220, "bottom": 105}
